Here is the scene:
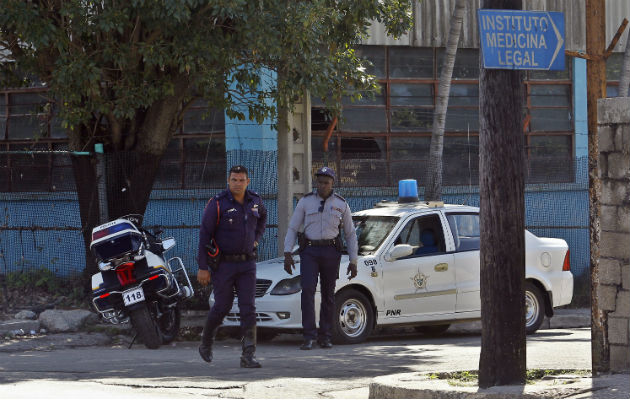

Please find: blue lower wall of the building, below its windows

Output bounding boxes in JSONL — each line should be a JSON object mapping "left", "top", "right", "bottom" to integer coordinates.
{"left": 0, "top": 181, "right": 589, "bottom": 276}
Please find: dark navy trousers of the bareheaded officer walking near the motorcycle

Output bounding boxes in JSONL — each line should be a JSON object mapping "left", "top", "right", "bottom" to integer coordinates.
{"left": 208, "top": 260, "right": 256, "bottom": 332}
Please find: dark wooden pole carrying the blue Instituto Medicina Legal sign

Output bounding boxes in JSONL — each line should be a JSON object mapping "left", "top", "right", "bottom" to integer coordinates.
{"left": 479, "top": 0, "right": 526, "bottom": 388}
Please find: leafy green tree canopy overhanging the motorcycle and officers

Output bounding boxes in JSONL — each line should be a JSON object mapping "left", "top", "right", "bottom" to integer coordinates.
{"left": 0, "top": 0, "right": 412, "bottom": 154}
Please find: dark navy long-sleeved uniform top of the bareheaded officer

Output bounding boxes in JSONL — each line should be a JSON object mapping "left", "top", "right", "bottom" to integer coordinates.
{"left": 197, "top": 190, "right": 267, "bottom": 270}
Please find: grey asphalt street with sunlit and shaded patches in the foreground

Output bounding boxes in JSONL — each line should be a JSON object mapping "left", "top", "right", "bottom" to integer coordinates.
{"left": 0, "top": 310, "right": 630, "bottom": 399}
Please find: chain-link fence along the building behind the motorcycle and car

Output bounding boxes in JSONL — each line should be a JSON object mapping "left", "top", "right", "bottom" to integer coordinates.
{"left": 0, "top": 152, "right": 589, "bottom": 304}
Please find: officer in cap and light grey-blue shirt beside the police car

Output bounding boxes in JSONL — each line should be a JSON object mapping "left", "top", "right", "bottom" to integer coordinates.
{"left": 284, "top": 167, "right": 358, "bottom": 350}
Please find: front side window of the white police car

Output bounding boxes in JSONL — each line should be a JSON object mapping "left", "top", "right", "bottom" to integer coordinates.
{"left": 394, "top": 214, "right": 445, "bottom": 257}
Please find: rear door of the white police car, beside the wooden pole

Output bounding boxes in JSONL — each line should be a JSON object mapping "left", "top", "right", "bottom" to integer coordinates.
{"left": 446, "top": 212, "right": 481, "bottom": 312}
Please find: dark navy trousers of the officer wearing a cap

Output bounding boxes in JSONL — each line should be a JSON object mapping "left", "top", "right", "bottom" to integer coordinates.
{"left": 300, "top": 245, "right": 341, "bottom": 340}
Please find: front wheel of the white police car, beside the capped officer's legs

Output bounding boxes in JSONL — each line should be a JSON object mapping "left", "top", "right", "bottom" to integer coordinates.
{"left": 332, "top": 289, "right": 374, "bottom": 344}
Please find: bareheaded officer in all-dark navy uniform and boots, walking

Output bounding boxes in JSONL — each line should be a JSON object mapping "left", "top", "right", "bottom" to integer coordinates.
{"left": 197, "top": 165, "right": 267, "bottom": 368}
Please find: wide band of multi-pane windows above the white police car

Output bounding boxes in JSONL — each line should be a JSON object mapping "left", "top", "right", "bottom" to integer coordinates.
{"left": 311, "top": 46, "right": 573, "bottom": 186}
